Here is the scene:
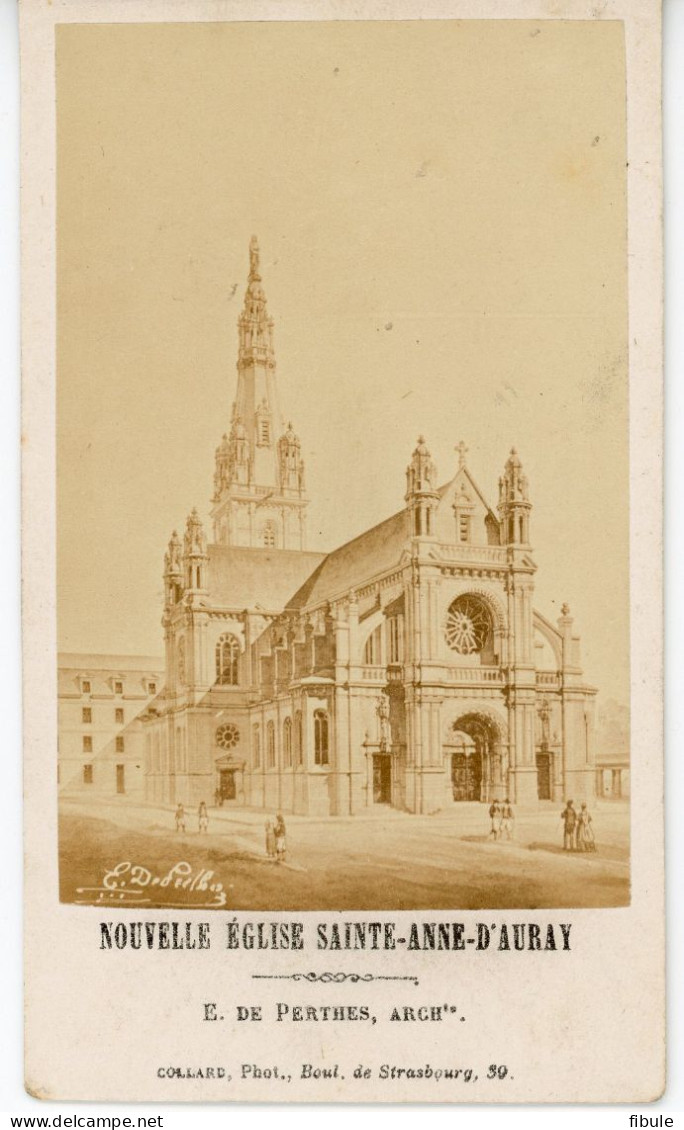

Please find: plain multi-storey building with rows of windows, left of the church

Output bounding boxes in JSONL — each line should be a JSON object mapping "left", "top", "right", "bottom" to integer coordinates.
{"left": 58, "top": 652, "right": 164, "bottom": 798}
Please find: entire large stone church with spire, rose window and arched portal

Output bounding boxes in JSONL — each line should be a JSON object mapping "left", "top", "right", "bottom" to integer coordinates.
{"left": 145, "top": 240, "right": 597, "bottom": 815}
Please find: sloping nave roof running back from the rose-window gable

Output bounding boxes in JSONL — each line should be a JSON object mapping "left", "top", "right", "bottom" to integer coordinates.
{"left": 287, "top": 510, "right": 408, "bottom": 609}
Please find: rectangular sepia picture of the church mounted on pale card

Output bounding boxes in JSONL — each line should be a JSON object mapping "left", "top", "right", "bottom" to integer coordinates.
{"left": 55, "top": 20, "right": 630, "bottom": 911}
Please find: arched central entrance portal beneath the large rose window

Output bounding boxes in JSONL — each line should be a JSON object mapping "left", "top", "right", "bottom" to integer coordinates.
{"left": 444, "top": 713, "right": 503, "bottom": 801}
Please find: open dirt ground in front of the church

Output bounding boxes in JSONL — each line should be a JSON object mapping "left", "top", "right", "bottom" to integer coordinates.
{"left": 60, "top": 798, "right": 630, "bottom": 911}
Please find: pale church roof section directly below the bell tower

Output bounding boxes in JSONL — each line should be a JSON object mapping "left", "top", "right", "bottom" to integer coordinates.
{"left": 208, "top": 545, "right": 324, "bottom": 612}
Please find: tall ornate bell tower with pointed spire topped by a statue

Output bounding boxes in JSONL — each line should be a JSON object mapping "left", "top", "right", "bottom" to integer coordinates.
{"left": 211, "top": 236, "right": 309, "bottom": 549}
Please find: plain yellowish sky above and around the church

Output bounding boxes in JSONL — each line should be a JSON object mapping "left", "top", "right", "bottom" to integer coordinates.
{"left": 57, "top": 20, "right": 629, "bottom": 702}
